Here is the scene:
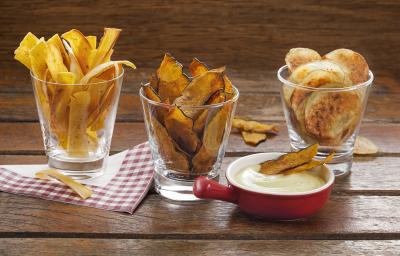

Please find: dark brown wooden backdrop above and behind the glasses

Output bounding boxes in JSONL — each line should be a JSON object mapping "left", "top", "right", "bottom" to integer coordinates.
{"left": 0, "top": 0, "right": 400, "bottom": 78}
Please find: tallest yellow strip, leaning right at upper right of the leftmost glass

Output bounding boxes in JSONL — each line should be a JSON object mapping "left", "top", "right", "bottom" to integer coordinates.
{"left": 90, "top": 28, "right": 121, "bottom": 69}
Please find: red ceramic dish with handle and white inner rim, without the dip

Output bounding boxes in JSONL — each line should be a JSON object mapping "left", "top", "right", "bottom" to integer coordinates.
{"left": 193, "top": 153, "right": 335, "bottom": 220}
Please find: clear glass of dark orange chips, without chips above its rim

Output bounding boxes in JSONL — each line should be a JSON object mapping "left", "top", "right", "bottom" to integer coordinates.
{"left": 140, "top": 85, "right": 239, "bottom": 201}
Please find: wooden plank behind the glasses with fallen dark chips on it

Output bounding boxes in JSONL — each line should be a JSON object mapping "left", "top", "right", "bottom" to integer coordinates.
{"left": 0, "top": 123, "right": 400, "bottom": 155}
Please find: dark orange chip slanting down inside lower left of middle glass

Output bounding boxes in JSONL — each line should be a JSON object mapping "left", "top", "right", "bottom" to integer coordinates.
{"left": 151, "top": 117, "right": 190, "bottom": 174}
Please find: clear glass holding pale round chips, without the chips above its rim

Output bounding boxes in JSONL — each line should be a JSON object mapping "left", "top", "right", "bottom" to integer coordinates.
{"left": 277, "top": 66, "right": 374, "bottom": 177}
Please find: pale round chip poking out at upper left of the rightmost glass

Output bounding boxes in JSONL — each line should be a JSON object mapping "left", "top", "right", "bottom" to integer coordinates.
{"left": 285, "top": 48, "right": 321, "bottom": 72}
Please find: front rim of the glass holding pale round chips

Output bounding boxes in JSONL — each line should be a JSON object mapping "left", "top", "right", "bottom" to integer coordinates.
{"left": 277, "top": 65, "right": 374, "bottom": 92}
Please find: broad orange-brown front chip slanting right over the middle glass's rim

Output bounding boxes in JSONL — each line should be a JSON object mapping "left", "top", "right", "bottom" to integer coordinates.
{"left": 174, "top": 68, "right": 225, "bottom": 119}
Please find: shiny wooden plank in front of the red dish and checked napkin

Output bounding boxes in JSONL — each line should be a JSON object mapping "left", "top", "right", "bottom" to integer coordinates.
{"left": 0, "top": 193, "right": 400, "bottom": 239}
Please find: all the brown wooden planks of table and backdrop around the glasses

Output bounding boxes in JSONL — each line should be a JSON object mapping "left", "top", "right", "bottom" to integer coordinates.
{"left": 0, "top": 0, "right": 400, "bottom": 255}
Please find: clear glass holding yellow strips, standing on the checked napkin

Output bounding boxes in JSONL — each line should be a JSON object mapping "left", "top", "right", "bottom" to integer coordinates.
{"left": 31, "top": 70, "right": 124, "bottom": 179}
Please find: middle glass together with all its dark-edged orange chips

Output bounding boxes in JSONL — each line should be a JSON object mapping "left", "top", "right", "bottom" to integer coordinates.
{"left": 140, "top": 54, "right": 239, "bottom": 201}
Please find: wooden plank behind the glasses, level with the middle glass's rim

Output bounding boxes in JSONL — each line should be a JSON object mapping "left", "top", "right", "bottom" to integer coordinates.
{"left": 0, "top": 93, "right": 400, "bottom": 123}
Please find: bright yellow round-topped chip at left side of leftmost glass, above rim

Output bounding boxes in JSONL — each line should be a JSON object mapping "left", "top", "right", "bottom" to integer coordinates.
{"left": 29, "top": 40, "right": 47, "bottom": 80}
